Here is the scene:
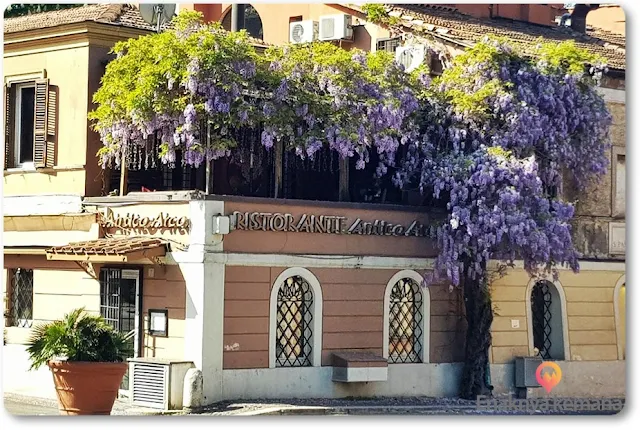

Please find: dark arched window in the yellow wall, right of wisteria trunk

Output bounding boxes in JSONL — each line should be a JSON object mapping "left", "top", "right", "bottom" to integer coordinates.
{"left": 527, "top": 280, "right": 569, "bottom": 360}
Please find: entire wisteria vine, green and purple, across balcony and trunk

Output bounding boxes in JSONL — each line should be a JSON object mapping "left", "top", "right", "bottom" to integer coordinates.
{"left": 91, "top": 12, "right": 611, "bottom": 285}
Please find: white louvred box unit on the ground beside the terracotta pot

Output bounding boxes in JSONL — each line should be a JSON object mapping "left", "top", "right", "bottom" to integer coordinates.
{"left": 128, "top": 358, "right": 195, "bottom": 411}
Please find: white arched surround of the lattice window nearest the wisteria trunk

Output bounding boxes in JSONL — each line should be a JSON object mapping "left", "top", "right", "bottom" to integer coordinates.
{"left": 382, "top": 270, "right": 431, "bottom": 366}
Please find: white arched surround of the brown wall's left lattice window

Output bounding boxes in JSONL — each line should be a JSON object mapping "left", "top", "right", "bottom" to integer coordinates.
{"left": 269, "top": 267, "right": 322, "bottom": 369}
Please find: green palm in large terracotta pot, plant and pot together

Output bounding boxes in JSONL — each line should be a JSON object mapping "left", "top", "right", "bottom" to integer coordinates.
{"left": 27, "top": 308, "right": 131, "bottom": 415}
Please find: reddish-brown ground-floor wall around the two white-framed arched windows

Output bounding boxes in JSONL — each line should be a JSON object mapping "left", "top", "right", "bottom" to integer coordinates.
{"left": 223, "top": 266, "right": 465, "bottom": 369}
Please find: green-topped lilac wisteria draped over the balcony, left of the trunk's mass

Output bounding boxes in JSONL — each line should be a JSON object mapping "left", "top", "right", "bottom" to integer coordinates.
{"left": 91, "top": 13, "right": 420, "bottom": 175}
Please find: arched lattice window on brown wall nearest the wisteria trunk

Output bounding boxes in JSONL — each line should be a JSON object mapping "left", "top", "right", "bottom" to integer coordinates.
{"left": 383, "top": 270, "right": 430, "bottom": 363}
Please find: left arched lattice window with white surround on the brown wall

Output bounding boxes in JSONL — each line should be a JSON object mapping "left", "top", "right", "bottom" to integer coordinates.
{"left": 269, "top": 267, "right": 322, "bottom": 367}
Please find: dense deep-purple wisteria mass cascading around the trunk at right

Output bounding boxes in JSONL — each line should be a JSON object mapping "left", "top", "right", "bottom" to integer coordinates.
{"left": 394, "top": 39, "right": 611, "bottom": 285}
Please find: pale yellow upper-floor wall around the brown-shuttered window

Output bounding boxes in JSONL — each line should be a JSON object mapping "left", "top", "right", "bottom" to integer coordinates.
{"left": 3, "top": 46, "right": 89, "bottom": 196}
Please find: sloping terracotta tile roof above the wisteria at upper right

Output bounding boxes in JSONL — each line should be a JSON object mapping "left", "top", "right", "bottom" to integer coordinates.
{"left": 386, "top": 4, "right": 626, "bottom": 70}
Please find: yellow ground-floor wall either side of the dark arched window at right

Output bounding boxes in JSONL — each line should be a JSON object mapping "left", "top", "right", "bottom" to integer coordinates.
{"left": 491, "top": 269, "right": 624, "bottom": 363}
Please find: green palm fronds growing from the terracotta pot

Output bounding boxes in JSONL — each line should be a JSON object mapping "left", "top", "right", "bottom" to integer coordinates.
{"left": 27, "top": 308, "right": 132, "bottom": 369}
